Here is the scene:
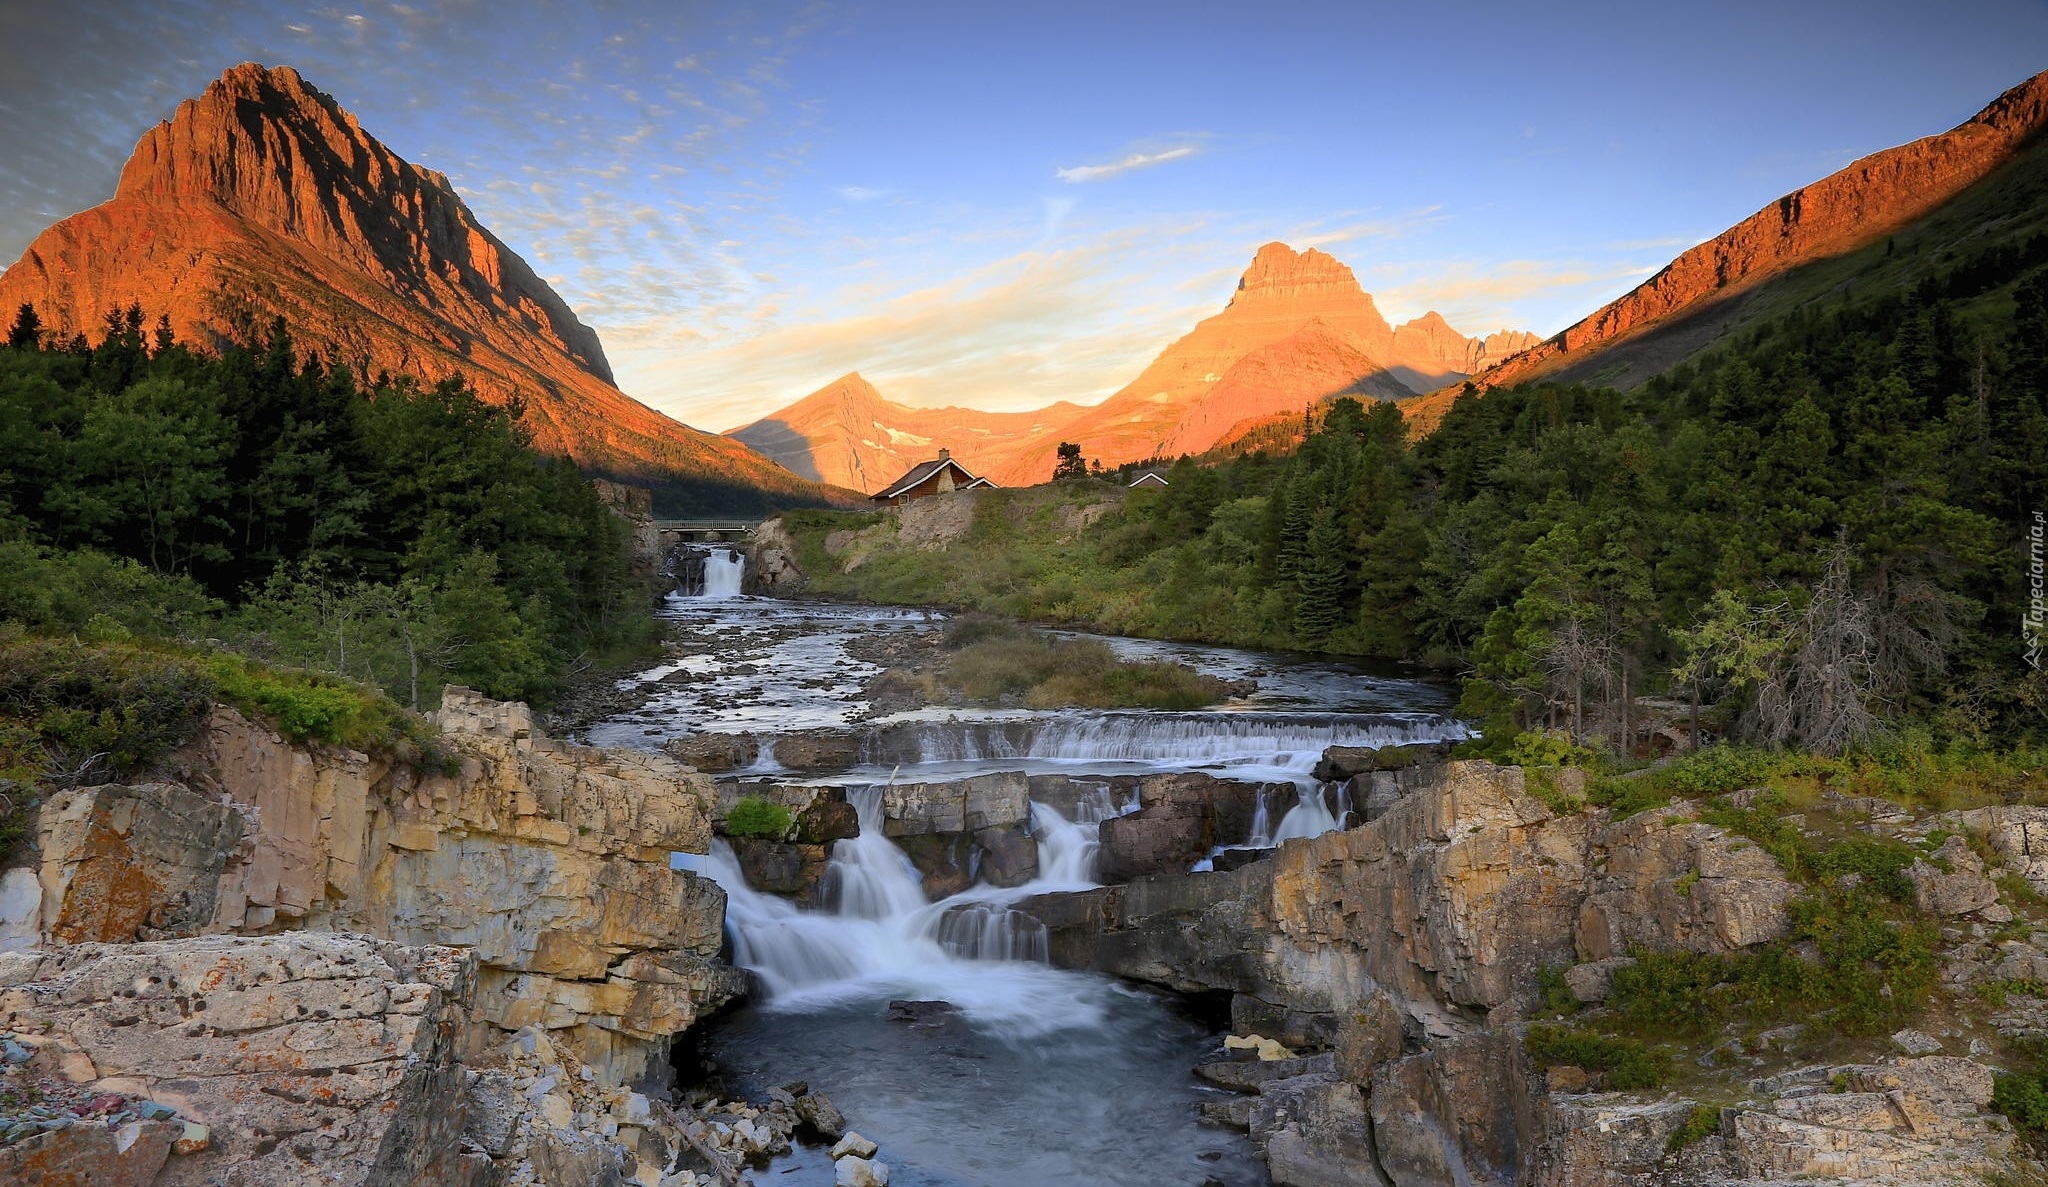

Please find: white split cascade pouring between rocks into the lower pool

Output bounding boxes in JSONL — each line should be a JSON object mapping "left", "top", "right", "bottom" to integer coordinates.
{"left": 705, "top": 786, "right": 1120, "bottom": 1034}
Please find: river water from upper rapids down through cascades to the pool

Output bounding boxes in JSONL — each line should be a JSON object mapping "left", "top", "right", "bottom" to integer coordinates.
{"left": 590, "top": 573, "right": 1462, "bottom": 1187}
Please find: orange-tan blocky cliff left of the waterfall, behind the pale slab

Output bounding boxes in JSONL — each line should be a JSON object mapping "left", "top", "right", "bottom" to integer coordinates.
{"left": 28, "top": 688, "right": 745, "bottom": 1083}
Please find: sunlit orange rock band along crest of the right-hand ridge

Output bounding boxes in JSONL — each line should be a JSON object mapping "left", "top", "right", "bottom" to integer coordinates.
{"left": 1449, "top": 72, "right": 2048, "bottom": 403}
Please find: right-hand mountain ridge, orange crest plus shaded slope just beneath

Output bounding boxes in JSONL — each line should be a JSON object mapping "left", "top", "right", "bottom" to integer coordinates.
{"left": 1409, "top": 72, "right": 2048, "bottom": 424}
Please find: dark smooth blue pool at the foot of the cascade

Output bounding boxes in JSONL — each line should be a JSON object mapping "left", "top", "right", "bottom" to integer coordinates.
{"left": 705, "top": 990, "right": 1268, "bottom": 1187}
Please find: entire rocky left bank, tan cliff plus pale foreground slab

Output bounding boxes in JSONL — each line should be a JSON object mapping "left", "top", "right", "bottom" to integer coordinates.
{"left": 0, "top": 688, "right": 753, "bottom": 1187}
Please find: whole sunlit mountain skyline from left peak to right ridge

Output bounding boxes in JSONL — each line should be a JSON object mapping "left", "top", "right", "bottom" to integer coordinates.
{"left": 0, "top": 63, "right": 2048, "bottom": 510}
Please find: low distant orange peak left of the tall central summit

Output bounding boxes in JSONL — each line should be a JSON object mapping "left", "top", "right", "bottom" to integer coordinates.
{"left": 727, "top": 372, "right": 1081, "bottom": 491}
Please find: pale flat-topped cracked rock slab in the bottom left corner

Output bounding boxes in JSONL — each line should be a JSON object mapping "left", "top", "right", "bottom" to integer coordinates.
{"left": 0, "top": 933, "right": 475, "bottom": 1187}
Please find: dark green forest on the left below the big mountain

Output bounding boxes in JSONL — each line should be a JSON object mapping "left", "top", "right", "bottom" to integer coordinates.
{"left": 0, "top": 305, "right": 651, "bottom": 706}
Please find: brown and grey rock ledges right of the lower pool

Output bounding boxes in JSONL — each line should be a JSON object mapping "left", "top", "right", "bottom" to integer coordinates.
{"left": 1016, "top": 755, "right": 2023, "bottom": 1187}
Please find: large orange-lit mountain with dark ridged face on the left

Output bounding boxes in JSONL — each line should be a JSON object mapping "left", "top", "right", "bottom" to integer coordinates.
{"left": 0, "top": 63, "right": 847, "bottom": 501}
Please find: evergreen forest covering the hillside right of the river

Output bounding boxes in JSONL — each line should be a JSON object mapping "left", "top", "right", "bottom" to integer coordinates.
{"left": 909, "top": 241, "right": 2048, "bottom": 753}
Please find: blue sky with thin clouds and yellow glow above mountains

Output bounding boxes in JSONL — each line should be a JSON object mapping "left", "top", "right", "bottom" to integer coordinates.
{"left": 0, "top": 0, "right": 2048, "bottom": 430}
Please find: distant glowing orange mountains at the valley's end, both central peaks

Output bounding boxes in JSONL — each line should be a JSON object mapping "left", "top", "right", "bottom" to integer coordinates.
{"left": 731, "top": 244, "right": 1536, "bottom": 489}
